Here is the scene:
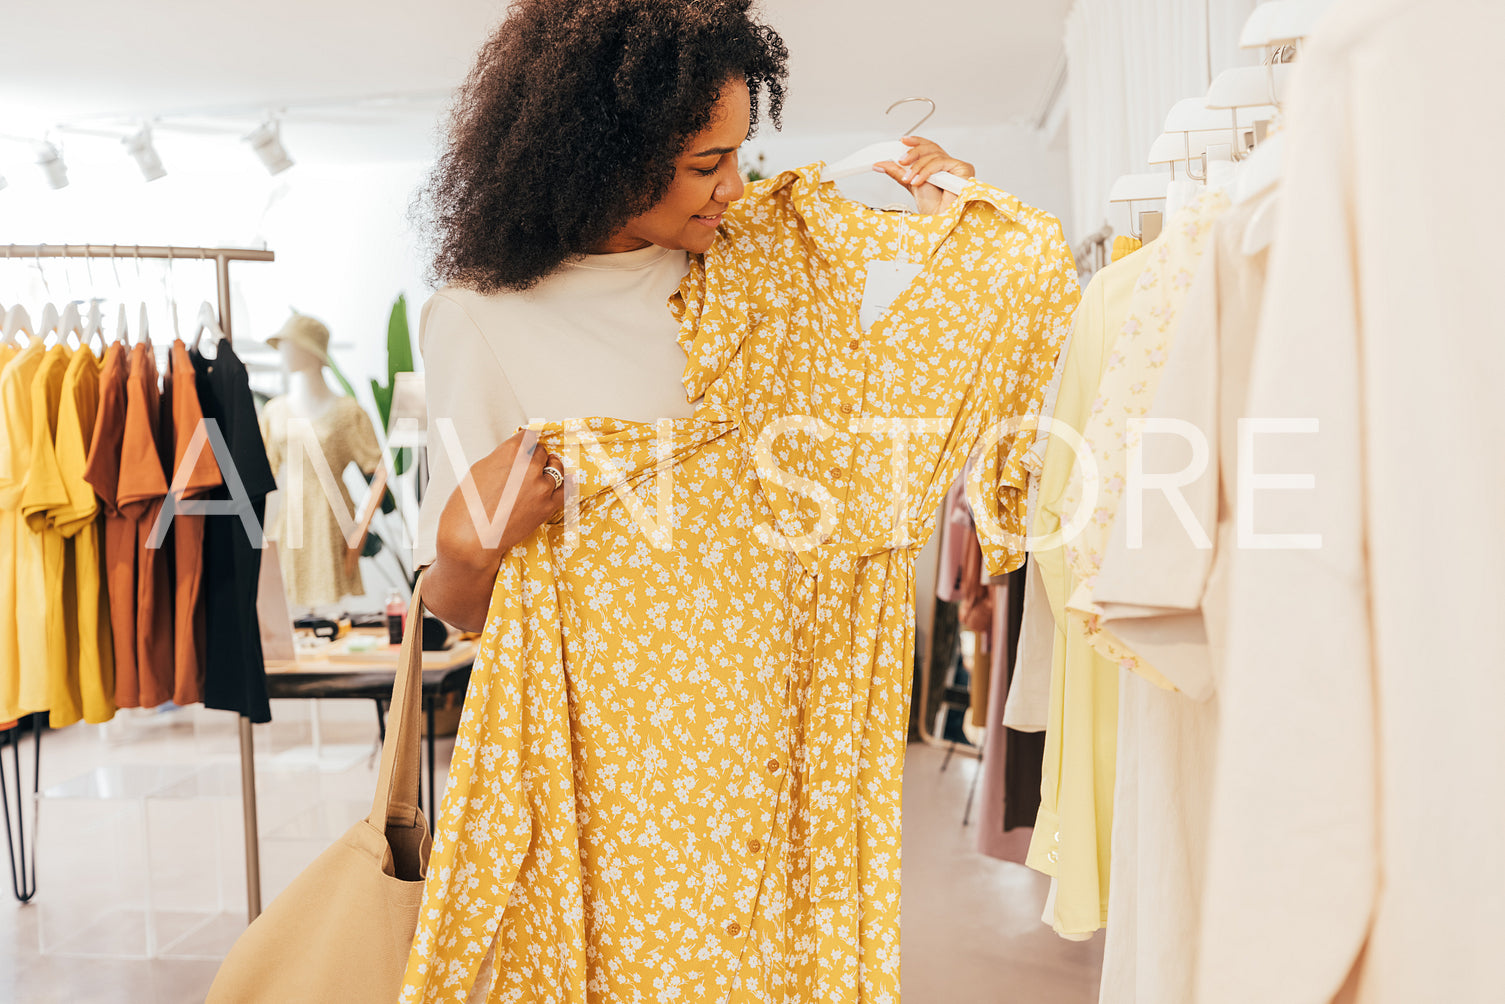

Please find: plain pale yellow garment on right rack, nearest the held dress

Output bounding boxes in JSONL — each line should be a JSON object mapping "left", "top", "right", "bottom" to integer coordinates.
{"left": 1026, "top": 244, "right": 1154, "bottom": 938}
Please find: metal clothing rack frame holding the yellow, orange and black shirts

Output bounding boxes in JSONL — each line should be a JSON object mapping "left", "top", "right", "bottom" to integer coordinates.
{"left": 0, "top": 244, "right": 277, "bottom": 920}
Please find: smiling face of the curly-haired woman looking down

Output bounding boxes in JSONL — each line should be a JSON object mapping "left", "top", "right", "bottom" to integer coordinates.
{"left": 600, "top": 80, "right": 751, "bottom": 253}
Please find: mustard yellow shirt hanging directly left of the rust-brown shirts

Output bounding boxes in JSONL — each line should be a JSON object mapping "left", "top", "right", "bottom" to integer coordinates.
{"left": 48, "top": 348, "right": 114, "bottom": 726}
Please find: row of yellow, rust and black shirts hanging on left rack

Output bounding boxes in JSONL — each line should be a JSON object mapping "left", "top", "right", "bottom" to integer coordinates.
{"left": 0, "top": 307, "right": 275, "bottom": 727}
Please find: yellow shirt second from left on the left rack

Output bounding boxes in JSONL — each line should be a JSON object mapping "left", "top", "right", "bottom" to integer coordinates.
{"left": 17, "top": 345, "right": 81, "bottom": 727}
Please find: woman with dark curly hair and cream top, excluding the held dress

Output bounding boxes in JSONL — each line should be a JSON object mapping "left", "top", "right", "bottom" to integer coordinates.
{"left": 417, "top": 0, "right": 972, "bottom": 631}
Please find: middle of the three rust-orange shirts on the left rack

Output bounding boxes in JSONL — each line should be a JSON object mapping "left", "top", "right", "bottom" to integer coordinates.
{"left": 116, "top": 343, "right": 173, "bottom": 707}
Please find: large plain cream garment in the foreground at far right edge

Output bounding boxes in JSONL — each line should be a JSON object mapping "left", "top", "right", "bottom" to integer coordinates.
{"left": 1198, "top": 0, "right": 1505, "bottom": 1004}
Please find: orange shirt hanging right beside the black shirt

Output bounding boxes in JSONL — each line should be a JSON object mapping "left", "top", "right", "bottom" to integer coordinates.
{"left": 163, "top": 339, "right": 221, "bottom": 704}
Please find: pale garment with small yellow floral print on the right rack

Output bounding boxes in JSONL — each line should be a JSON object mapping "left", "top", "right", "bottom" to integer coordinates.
{"left": 1066, "top": 190, "right": 1228, "bottom": 688}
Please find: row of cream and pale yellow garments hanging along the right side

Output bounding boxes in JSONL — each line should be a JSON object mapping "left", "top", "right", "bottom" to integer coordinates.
{"left": 1004, "top": 0, "right": 1505, "bottom": 1004}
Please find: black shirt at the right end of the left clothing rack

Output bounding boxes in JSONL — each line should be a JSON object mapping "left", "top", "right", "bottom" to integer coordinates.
{"left": 188, "top": 340, "right": 277, "bottom": 723}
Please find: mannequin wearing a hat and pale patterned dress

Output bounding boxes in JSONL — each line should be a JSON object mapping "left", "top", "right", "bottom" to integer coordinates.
{"left": 262, "top": 313, "right": 381, "bottom": 608}
